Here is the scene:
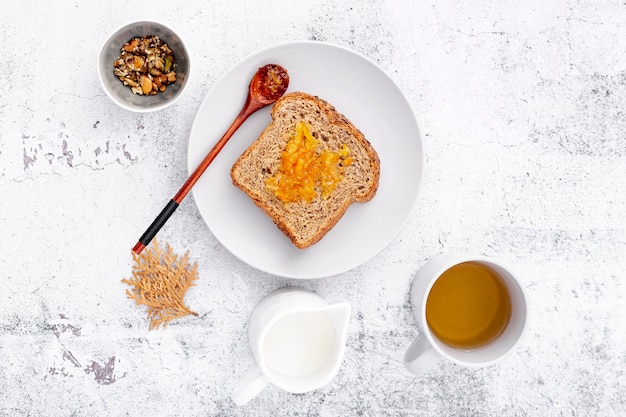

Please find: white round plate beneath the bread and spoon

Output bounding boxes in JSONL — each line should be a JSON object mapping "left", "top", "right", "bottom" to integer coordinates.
{"left": 188, "top": 41, "right": 424, "bottom": 279}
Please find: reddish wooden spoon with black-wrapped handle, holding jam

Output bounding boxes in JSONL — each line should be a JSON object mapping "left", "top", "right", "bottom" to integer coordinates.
{"left": 133, "top": 64, "right": 289, "bottom": 255}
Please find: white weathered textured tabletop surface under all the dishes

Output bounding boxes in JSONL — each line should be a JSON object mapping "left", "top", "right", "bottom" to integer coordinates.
{"left": 0, "top": 0, "right": 626, "bottom": 417}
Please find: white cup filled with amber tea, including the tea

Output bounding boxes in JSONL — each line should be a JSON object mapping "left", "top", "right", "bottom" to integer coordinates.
{"left": 404, "top": 254, "right": 528, "bottom": 375}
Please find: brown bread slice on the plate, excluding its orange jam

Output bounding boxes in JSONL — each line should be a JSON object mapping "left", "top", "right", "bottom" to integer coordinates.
{"left": 230, "top": 92, "right": 380, "bottom": 249}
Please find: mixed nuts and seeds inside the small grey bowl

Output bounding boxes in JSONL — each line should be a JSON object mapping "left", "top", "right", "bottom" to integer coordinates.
{"left": 113, "top": 36, "right": 176, "bottom": 95}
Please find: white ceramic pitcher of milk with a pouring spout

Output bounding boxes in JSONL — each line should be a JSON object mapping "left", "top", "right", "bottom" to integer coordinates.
{"left": 231, "top": 287, "right": 350, "bottom": 405}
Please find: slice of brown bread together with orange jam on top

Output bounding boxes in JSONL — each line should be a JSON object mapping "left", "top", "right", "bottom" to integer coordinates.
{"left": 231, "top": 92, "right": 380, "bottom": 249}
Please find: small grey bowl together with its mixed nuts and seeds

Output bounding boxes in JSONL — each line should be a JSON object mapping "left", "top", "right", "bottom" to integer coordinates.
{"left": 98, "top": 21, "right": 191, "bottom": 112}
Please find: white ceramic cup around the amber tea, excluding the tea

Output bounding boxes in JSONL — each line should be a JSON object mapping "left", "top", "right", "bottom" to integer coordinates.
{"left": 404, "top": 254, "right": 528, "bottom": 375}
